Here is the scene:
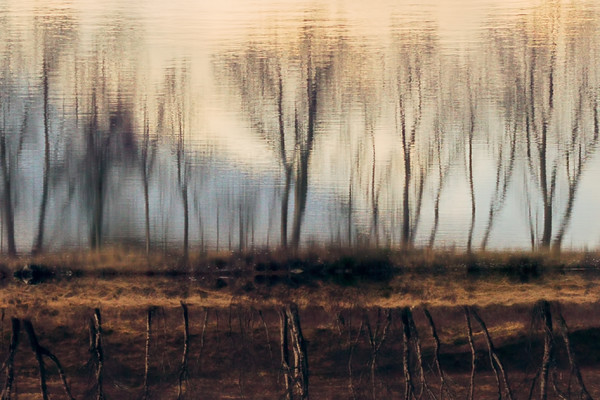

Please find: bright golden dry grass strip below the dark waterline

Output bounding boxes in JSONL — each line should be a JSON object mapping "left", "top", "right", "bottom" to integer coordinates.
{"left": 0, "top": 273, "right": 600, "bottom": 311}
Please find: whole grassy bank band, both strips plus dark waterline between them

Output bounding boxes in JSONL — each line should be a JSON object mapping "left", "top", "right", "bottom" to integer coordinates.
{"left": 0, "top": 248, "right": 600, "bottom": 309}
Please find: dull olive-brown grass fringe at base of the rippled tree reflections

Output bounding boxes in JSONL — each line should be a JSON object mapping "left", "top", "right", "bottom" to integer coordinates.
{"left": 0, "top": 246, "right": 600, "bottom": 274}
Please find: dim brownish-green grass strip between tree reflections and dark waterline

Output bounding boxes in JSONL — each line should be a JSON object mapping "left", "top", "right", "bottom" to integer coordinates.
{"left": 0, "top": 247, "right": 600, "bottom": 276}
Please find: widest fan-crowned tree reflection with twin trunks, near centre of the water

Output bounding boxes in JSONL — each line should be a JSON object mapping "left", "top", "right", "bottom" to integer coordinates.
{"left": 222, "top": 21, "right": 333, "bottom": 249}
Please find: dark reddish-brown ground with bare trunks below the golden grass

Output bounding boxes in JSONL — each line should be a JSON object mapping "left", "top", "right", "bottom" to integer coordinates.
{"left": 2, "top": 300, "right": 600, "bottom": 399}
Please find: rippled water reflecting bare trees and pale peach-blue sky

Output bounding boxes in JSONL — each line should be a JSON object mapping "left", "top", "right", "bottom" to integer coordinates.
{"left": 0, "top": 0, "right": 600, "bottom": 252}
